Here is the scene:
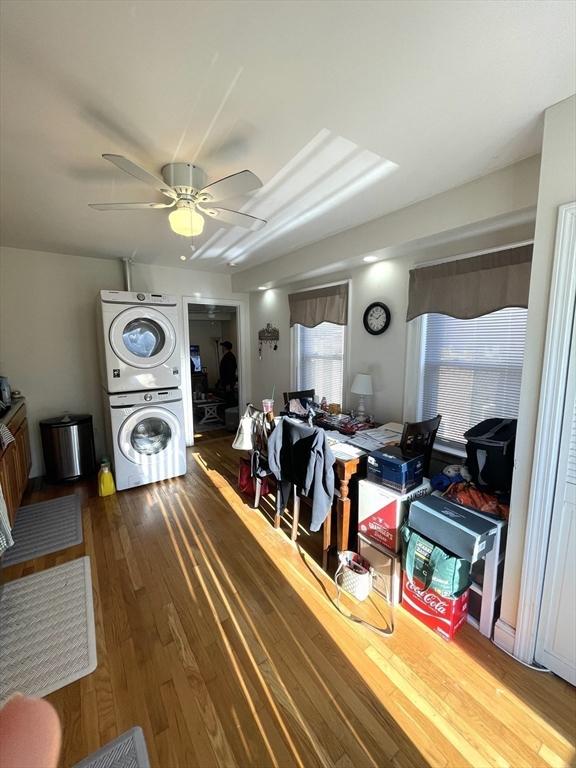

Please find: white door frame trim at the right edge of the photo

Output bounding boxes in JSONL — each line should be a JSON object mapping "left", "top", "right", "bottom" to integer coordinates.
{"left": 514, "top": 202, "right": 576, "bottom": 664}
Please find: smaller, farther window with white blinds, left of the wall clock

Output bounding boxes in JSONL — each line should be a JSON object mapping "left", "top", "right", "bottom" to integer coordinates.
{"left": 294, "top": 323, "right": 345, "bottom": 403}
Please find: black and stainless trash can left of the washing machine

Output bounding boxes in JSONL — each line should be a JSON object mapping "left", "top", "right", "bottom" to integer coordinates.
{"left": 40, "top": 414, "right": 96, "bottom": 483}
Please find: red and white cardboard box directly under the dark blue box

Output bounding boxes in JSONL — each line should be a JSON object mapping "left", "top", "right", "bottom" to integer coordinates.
{"left": 358, "top": 480, "right": 432, "bottom": 559}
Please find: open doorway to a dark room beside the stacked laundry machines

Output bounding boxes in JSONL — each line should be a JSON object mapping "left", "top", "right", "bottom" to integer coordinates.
{"left": 183, "top": 299, "right": 242, "bottom": 445}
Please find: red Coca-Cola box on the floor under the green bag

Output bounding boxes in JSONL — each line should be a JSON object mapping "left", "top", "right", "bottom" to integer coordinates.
{"left": 402, "top": 573, "right": 470, "bottom": 640}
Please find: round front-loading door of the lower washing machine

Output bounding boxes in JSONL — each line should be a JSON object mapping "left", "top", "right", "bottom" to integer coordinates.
{"left": 118, "top": 407, "right": 181, "bottom": 464}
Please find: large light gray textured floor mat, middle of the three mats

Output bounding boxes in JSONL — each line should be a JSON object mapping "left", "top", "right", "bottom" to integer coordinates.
{"left": 0, "top": 557, "right": 96, "bottom": 701}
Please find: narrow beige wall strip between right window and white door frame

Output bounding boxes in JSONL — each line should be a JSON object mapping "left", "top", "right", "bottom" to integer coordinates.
{"left": 501, "top": 96, "right": 576, "bottom": 627}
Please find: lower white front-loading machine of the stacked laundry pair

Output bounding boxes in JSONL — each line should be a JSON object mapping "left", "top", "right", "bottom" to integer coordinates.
{"left": 105, "top": 389, "right": 186, "bottom": 491}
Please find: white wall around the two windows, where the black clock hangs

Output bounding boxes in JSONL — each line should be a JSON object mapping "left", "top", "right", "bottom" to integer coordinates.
{"left": 250, "top": 216, "right": 534, "bottom": 421}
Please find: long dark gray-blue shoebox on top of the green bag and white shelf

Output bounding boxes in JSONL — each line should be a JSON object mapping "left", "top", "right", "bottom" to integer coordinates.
{"left": 408, "top": 496, "right": 496, "bottom": 563}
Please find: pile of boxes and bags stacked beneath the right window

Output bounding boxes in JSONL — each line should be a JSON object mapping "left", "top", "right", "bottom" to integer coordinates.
{"left": 357, "top": 419, "right": 516, "bottom": 640}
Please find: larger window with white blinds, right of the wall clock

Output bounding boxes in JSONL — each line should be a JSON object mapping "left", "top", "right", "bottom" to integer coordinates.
{"left": 418, "top": 307, "right": 527, "bottom": 449}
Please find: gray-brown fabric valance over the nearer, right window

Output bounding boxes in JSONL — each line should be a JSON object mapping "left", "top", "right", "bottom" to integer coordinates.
{"left": 406, "top": 245, "right": 532, "bottom": 320}
